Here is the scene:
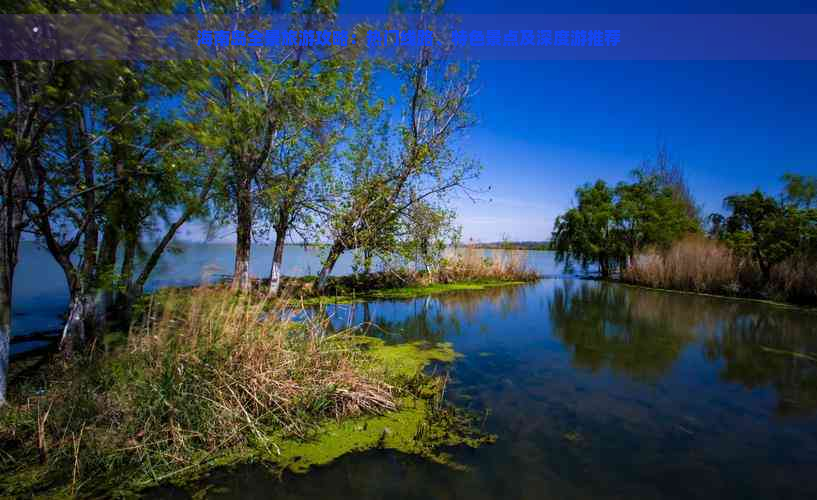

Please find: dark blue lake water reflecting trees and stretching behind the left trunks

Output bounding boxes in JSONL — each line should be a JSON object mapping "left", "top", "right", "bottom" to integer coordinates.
{"left": 15, "top": 246, "right": 817, "bottom": 500}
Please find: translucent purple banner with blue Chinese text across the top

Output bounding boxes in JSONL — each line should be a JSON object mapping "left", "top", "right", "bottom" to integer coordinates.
{"left": 0, "top": 14, "right": 817, "bottom": 61}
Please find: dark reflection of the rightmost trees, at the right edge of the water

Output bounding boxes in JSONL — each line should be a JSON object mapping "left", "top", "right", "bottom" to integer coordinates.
{"left": 704, "top": 307, "right": 817, "bottom": 415}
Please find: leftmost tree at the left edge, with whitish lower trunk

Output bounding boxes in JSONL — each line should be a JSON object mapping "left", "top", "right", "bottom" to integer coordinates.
{"left": 0, "top": 0, "right": 176, "bottom": 402}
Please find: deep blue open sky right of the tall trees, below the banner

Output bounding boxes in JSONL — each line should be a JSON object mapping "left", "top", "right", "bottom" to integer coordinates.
{"left": 188, "top": 0, "right": 817, "bottom": 241}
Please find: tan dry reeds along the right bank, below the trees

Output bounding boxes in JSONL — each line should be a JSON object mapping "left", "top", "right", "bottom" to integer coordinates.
{"left": 622, "top": 235, "right": 817, "bottom": 305}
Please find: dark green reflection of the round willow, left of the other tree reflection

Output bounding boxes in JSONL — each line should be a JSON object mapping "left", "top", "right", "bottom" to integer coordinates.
{"left": 549, "top": 281, "right": 694, "bottom": 380}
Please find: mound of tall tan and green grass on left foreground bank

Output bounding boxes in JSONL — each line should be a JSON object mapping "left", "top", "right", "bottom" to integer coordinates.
{"left": 0, "top": 287, "right": 404, "bottom": 495}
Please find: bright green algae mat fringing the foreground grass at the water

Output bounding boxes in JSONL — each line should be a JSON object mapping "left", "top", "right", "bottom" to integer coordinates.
{"left": 0, "top": 336, "right": 496, "bottom": 498}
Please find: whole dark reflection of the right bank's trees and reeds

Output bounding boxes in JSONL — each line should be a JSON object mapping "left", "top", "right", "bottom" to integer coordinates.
{"left": 550, "top": 281, "right": 817, "bottom": 415}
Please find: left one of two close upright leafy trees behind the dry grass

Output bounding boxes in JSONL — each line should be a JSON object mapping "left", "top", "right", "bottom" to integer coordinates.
{"left": 184, "top": 0, "right": 356, "bottom": 291}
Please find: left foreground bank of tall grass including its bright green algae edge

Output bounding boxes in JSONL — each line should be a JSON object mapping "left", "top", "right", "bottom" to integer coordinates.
{"left": 0, "top": 287, "right": 490, "bottom": 497}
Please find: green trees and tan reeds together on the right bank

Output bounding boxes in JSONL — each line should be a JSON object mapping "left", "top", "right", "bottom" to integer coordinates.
{"left": 553, "top": 147, "right": 817, "bottom": 306}
